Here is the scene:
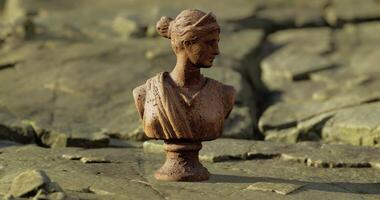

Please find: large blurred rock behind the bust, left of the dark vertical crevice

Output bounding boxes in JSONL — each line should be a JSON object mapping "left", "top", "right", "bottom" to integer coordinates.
{"left": 0, "top": 0, "right": 264, "bottom": 147}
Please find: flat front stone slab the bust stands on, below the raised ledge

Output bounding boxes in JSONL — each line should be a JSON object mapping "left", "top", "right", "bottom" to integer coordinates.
{"left": 0, "top": 141, "right": 380, "bottom": 200}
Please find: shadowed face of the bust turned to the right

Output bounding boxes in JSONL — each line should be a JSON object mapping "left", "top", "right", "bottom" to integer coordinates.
{"left": 184, "top": 31, "right": 219, "bottom": 68}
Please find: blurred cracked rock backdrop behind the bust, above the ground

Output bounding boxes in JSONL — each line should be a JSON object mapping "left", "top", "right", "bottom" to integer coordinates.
{"left": 0, "top": 0, "right": 380, "bottom": 147}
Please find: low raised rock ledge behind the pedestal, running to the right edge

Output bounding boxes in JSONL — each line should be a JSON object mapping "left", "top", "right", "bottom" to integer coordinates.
{"left": 143, "top": 139, "right": 380, "bottom": 168}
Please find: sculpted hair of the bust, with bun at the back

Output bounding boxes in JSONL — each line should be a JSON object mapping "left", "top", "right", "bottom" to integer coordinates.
{"left": 156, "top": 9, "right": 220, "bottom": 51}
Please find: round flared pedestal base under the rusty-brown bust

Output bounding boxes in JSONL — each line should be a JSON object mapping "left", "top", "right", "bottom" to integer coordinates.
{"left": 154, "top": 141, "right": 210, "bottom": 181}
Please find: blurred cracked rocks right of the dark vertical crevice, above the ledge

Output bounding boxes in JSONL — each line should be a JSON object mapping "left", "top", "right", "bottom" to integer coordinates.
{"left": 259, "top": 22, "right": 380, "bottom": 146}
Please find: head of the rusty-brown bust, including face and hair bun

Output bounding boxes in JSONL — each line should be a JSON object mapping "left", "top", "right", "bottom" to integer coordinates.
{"left": 156, "top": 9, "right": 220, "bottom": 68}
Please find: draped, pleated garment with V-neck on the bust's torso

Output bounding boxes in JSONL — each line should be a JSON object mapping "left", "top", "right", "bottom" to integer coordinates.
{"left": 143, "top": 72, "right": 232, "bottom": 141}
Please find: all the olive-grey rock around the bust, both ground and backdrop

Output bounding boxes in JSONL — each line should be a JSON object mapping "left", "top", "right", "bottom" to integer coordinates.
{"left": 0, "top": 0, "right": 380, "bottom": 199}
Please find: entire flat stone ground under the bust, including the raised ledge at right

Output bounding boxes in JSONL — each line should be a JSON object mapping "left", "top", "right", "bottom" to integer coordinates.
{"left": 0, "top": 139, "right": 380, "bottom": 200}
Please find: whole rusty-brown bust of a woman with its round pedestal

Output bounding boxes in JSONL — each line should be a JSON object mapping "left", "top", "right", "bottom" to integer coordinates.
{"left": 133, "top": 9, "right": 236, "bottom": 181}
